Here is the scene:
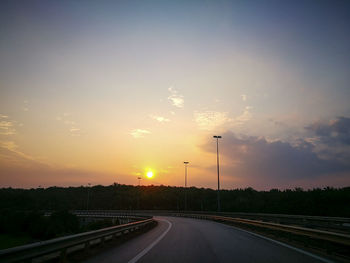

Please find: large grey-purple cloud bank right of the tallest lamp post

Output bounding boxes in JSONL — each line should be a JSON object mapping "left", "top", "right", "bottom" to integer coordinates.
{"left": 202, "top": 132, "right": 350, "bottom": 188}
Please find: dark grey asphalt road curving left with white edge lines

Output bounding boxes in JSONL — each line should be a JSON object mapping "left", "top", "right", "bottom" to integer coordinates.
{"left": 82, "top": 217, "right": 331, "bottom": 263}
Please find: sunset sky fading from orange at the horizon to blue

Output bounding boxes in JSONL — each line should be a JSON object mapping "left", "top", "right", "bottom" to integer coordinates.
{"left": 0, "top": 0, "right": 350, "bottom": 190}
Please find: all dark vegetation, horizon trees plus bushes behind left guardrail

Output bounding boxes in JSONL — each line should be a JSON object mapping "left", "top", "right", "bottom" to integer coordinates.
{"left": 0, "top": 186, "right": 350, "bottom": 249}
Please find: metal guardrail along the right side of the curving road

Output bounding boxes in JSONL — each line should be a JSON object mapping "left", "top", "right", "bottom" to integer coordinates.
{"left": 72, "top": 210, "right": 350, "bottom": 260}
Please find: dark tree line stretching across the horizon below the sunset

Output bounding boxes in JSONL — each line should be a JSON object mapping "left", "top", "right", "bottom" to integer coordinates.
{"left": 0, "top": 183, "right": 350, "bottom": 217}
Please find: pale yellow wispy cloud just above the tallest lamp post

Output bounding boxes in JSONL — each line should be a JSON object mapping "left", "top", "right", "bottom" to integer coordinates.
{"left": 194, "top": 111, "right": 231, "bottom": 130}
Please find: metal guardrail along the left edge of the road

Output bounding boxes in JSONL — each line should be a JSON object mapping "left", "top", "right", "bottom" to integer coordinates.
{"left": 0, "top": 217, "right": 154, "bottom": 263}
